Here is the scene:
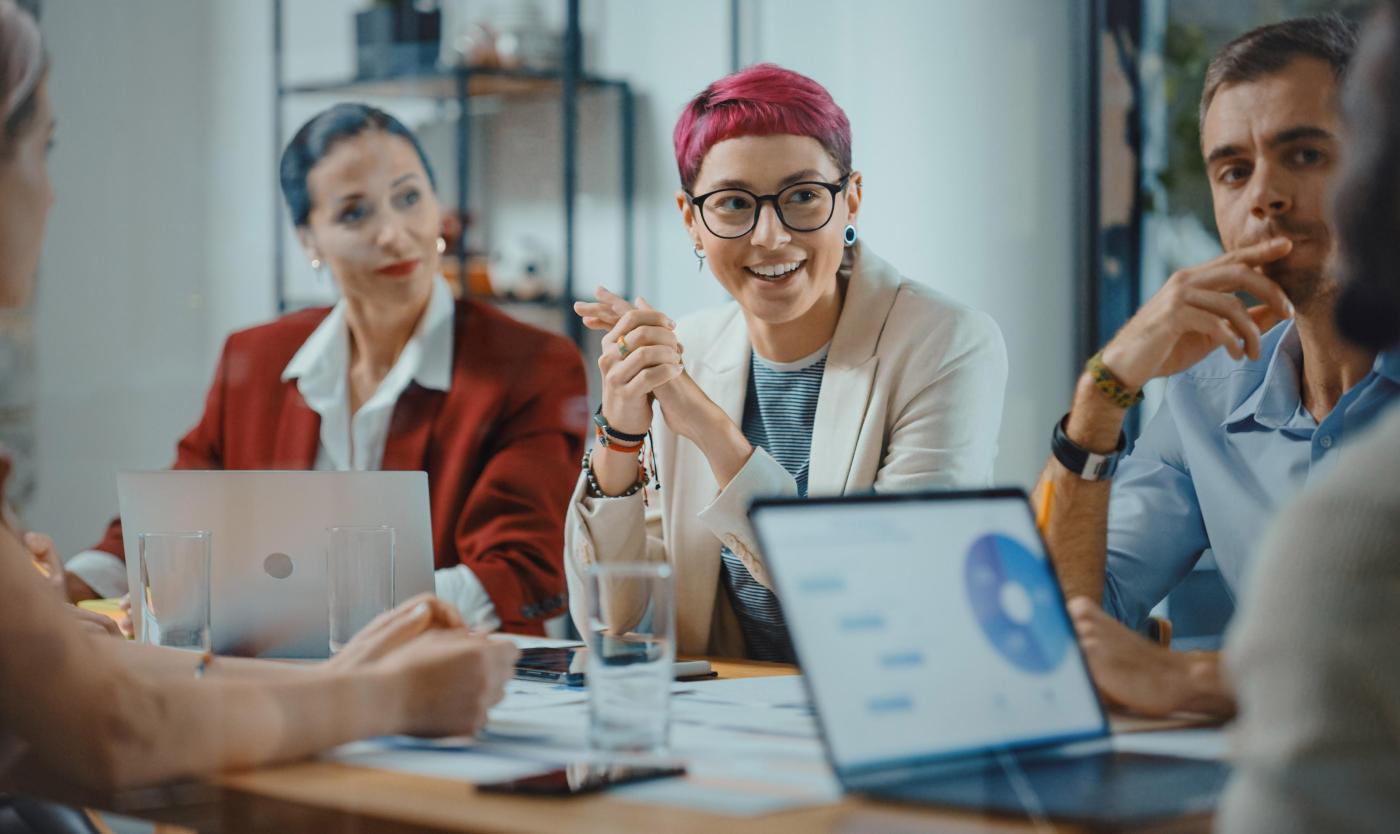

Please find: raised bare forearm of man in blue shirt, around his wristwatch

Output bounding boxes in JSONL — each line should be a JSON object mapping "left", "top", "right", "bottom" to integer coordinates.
{"left": 1036, "top": 376, "right": 1124, "bottom": 603}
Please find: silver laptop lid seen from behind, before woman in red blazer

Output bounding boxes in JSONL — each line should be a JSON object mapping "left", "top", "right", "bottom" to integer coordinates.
{"left": 116, "top": 470, "right": 433, "bottom": 658}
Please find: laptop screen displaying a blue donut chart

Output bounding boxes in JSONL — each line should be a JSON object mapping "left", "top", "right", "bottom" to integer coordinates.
{"left": 753, "top": 491, "right": 1106, "bottom": 771}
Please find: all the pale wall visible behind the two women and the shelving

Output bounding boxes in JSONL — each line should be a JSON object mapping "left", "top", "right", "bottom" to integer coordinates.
{"left": 29, "top": 0, "right": 1075, "bottom": 551}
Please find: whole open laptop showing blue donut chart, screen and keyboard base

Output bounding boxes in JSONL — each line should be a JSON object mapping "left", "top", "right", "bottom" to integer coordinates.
{"left": 750, "top": 490, "right": 1228, "bottom": 824}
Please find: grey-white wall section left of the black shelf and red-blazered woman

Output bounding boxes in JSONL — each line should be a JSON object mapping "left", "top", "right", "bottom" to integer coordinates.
{"left": 27, "top": 0, "right": 221, "bottom": 553}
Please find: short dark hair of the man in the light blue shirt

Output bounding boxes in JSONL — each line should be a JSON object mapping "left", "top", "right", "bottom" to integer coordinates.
{"left": 1200, "top": 13, "right": 1357, "bottom": 129}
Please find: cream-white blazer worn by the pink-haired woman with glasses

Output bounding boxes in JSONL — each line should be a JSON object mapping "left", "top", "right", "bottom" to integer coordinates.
{"left": 564, "top": 246, "right": 1007, "bottom": 656}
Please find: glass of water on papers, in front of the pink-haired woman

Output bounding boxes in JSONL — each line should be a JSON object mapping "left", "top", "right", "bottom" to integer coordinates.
{"left": 584, "top": 563, "right": 676, "bottom": 753}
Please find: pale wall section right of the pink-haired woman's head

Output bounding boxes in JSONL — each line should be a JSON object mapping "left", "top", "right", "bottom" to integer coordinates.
{"left": 746, "top": 0, "right": 1077, "bottom": 486}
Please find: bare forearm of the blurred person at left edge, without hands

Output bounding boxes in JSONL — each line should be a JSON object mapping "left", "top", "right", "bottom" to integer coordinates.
{"left": 0, "top": 535, "right": 405, "bottom": 788}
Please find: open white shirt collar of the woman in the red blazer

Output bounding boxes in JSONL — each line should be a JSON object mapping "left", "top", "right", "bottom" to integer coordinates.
{"left": 281, "top": 280, "right": 452, "bottom": 400}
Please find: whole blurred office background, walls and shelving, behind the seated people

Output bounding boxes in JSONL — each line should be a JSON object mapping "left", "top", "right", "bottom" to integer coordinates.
{"left": 0, "top": 0, "right": 1368, "bottom": 634}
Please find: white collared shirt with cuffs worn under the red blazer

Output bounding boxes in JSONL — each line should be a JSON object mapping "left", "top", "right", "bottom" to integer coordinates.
{"left": 66, "top": 281, "right": 500, "bottom": 628}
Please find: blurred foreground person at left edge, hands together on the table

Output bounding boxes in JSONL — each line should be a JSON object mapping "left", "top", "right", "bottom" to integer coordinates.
{"left": 0, "top": 0, "right": 515, "bottom": 788}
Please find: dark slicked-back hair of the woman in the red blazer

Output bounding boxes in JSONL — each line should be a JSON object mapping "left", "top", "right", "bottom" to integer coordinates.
{"left": 279, "top": 104, "right": 437, "bottom": 227}
